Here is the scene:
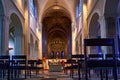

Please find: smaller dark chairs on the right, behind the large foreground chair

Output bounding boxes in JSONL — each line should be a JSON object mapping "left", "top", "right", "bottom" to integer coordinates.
{"left": 64, "top": 54, "right": 120, "bottom": 80}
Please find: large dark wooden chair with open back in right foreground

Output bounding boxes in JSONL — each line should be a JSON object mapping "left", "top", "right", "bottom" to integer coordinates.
{"left": 84, "top": 38, "right": 117, "bottom": 80}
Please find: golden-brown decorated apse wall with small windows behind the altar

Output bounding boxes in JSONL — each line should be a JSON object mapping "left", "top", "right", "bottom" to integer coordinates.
{"left": 49, "top": 39, "right": 65, "bottom": 59}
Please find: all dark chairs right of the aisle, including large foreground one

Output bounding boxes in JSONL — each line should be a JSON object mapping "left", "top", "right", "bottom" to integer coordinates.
{"left": 64, "top": 38, "right": 120, "bottom": 80}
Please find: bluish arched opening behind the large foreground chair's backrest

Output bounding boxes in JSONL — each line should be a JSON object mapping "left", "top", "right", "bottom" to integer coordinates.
{"left": 89, "top": 13, "right": 101, "bottom": 54}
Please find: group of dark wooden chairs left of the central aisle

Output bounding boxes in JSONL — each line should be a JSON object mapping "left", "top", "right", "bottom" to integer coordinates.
{"left": 0, "top": 55, "right": 43, "bottom": 80}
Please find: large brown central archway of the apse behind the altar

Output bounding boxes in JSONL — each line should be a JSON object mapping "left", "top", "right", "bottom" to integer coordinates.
{"left": 42, "top": 6, "right": 72, "bottom": 58}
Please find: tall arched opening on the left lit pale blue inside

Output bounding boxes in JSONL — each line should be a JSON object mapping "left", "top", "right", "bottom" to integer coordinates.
{"left": 9, "top": 13, "right": 23, "bottom": 55}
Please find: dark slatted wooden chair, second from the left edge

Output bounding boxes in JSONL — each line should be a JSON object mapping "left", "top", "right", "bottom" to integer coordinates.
{"left": 12, "top": 55, "right": 27, "bottom": 79}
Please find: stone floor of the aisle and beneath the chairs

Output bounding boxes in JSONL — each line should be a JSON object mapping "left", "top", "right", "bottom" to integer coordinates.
{"left": 0, "top": 71, "right": 120, "bottom": 80}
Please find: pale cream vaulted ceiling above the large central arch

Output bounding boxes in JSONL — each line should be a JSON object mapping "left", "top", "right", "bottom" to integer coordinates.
{"left": 36, "top": 0, "right": 76, "bottom": 22}
